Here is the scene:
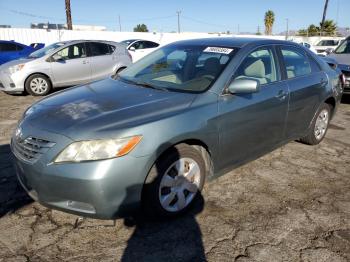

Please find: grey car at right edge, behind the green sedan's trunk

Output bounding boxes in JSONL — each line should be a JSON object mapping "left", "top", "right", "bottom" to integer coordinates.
{"left": 327, "top": 37, "right": 350, "bottom": 94}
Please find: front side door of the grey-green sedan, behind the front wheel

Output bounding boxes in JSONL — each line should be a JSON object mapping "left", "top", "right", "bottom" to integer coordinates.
{"left": 219, "top": 46, "right": 288, "bottom": 167}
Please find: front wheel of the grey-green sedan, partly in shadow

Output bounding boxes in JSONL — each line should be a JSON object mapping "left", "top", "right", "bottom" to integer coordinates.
{"left": 142, "top": 144, "right": 208, "bottom": 218}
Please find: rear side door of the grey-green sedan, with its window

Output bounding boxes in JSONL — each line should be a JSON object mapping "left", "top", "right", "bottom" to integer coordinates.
{"left": 280, "top": 46, "right": 328, "bottom": 138}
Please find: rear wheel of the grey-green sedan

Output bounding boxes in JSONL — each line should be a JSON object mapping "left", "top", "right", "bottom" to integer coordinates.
{"left": 300, "top": 103, "right": 331, "bottom": 145}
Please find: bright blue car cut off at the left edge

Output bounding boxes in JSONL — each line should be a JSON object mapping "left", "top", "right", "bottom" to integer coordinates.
{"left": 0, "top": 40, "right": 45, "bottom": 65}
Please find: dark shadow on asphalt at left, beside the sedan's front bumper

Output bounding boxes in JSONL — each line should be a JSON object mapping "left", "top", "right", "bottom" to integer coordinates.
{"left": 0, "top": 144, "right": 32, "bottom": 217}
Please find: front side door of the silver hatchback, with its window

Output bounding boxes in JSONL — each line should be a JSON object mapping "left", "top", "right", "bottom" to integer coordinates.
{"left": 50, "top": 43, "right": 91, "bottom": 86}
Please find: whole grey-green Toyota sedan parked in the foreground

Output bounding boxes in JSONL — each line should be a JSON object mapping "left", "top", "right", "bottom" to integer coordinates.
{"left": 11, "top": 38, "right": 341, "bottom": 219}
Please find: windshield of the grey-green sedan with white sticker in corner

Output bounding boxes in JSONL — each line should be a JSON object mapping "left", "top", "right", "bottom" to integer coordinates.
{"left": 118, "top": 44, "right": 238, "bottom": 92}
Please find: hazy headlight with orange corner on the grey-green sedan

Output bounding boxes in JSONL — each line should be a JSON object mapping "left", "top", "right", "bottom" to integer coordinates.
{"left": 54, "top": 136, "right": 142, "bottom": 163}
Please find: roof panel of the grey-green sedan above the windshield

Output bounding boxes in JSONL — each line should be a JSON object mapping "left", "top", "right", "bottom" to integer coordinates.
{"left": 170, "top": 37, "right": 297, "bottom": 48}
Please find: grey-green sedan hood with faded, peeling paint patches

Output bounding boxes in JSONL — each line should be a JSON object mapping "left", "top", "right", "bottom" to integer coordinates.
{"left": 24, "top": 78, "right": 196, "bottom": 139}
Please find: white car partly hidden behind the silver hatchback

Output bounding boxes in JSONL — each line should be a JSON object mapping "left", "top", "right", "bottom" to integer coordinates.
{"left": 120, "top": 39, "right": 159, "bottom": 62}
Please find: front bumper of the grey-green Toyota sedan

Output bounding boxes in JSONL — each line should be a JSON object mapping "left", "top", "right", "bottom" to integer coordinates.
{"left": 11, "top": 127, "right": 150, "bottom": 219}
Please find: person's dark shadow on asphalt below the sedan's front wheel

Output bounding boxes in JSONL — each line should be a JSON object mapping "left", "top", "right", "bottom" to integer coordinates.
{"left": 121, "top": 144, "right": 206, "bottom": 262}
